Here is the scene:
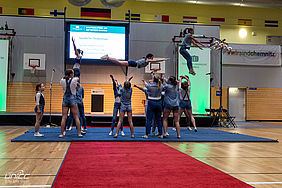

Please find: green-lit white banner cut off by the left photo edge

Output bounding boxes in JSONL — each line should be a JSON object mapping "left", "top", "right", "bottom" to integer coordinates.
{"left": 0, "top": 40, "right": 9, "bottom": 111}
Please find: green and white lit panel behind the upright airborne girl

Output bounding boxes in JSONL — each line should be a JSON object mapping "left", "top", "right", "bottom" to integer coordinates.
{"left": 178, "top": 47, "right": 210, "bottom": 114}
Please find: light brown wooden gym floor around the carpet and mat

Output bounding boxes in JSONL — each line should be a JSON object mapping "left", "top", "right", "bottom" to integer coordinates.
{"left": 0, "top": 122, "right": 282, "bottom": 188}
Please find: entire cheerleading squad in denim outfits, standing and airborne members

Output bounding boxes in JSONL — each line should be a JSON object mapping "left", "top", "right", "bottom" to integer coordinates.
{"left": 34, "top": 28, "right": 200, "bottom": 139}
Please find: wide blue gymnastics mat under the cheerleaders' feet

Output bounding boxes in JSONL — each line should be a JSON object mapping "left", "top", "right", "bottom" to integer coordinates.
{"left": 11, "top": 128, "right": 278, "bottom": 142}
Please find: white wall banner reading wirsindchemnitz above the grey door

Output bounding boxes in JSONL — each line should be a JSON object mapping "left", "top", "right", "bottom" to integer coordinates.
{"left": 223, "top": 44, "right": 281, "bottom": 66}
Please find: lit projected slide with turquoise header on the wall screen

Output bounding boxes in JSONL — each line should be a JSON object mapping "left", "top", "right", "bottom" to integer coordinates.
{"left": 67, "top": 24, "right": 126, "bottom": 60}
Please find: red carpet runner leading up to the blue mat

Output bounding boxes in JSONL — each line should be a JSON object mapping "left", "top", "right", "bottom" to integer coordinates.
{"left": 53, "top": 142, "right": 251, "bottom": 188}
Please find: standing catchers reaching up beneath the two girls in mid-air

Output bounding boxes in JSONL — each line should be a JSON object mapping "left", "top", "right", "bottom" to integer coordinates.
{"left": 109, "top": 72, "right": 197, "bottom": 138}
